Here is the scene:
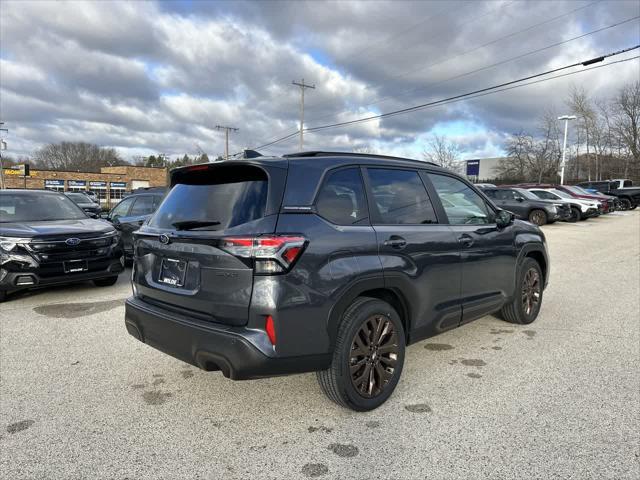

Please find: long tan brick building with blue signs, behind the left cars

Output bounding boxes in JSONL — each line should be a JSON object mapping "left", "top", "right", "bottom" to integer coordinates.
{"left": 3, "top": 165, "right": 167, "bottom": 208}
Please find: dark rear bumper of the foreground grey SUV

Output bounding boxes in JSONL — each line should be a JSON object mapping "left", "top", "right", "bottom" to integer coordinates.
{"left": 125, "top": 297, "right": 331, "bottom": 380}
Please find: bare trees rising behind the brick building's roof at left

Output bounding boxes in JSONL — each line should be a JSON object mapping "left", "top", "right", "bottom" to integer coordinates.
{"left": 33, "top": 142, "right": 128, "bottom": 172}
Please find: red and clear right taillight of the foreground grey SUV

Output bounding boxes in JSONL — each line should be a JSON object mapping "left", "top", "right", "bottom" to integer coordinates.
{"left": 220, "top": 235, "right": 307, "bottom": 274}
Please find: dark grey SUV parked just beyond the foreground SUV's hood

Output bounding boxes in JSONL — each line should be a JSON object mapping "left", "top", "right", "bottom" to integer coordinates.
{"left": 482, "top": 187, "right": 571, "bottom": 226}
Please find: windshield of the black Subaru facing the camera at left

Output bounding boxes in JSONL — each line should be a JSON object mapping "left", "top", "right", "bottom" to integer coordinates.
{"left": 0, "top": 192, "right": 87, "bottom": 223}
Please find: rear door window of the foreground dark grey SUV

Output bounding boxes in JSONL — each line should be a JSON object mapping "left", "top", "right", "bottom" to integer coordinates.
{"left": 367, "top": 168, "right": 438, "bottom": 225}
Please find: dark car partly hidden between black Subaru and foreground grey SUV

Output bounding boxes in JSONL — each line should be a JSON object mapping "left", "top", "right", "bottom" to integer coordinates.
{"left": 105, "top": 189, "right": 164, "bottom": 257}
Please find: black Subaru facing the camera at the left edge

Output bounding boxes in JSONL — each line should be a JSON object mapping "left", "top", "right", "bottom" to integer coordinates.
{"left": 0, "top": 190, "right": 124, "bottom": 301}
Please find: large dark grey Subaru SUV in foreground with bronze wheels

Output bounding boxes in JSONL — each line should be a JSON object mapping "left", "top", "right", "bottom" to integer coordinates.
{"left": 125, "top": 152, "right": 549, "bottom": 411}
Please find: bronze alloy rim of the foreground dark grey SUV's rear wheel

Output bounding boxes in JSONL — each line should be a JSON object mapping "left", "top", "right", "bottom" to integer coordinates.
{"left": 349, "top": 315, "right": 399, "bottom": 398}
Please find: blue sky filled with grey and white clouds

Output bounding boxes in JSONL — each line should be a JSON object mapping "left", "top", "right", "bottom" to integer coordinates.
{"left": 0, "top": 0, "right": 640, "bottom": 158}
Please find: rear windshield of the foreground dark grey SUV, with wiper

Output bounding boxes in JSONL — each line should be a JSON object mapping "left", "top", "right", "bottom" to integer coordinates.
{"left": 149, "top": 166, "right": 268, "bottom": 230}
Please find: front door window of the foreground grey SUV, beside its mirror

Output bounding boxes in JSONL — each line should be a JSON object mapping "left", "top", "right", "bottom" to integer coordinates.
{"left": 429, "top": 173, "right": 494, "bottom": 225}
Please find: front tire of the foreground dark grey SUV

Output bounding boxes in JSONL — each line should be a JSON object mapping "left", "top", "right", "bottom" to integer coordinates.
{"left": 500, "top": 258, "right": 544, "bottom": 325}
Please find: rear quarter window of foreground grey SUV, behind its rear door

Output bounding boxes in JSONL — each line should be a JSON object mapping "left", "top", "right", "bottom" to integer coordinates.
{"left": 316, "top": 168, "right": 369, "bottom": 225}
